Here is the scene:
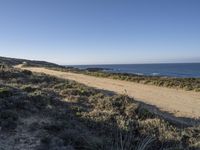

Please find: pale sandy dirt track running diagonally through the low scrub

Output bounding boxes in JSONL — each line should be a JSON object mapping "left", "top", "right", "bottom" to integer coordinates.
{"left": 18, "top": 66, "right": 200, "bottom": 119}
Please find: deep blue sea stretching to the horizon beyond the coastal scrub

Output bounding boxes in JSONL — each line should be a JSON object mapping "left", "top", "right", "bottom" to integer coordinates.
{"left": 68, "top": 63, "right": 200, "bottom": 78}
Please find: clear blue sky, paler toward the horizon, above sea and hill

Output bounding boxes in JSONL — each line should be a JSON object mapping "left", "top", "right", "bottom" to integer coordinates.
{"left": 0, "top": 0, "right": 200, "bottom": 64}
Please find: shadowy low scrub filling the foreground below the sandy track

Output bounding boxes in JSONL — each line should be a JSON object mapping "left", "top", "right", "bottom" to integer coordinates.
{"left": 0, "top": 61, "right": 200, "bottom": 150}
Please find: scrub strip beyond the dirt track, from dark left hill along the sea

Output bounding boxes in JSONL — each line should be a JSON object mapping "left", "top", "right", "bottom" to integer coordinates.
{"left": 0, "top": 57, "right": 200, "bottom": 92}
